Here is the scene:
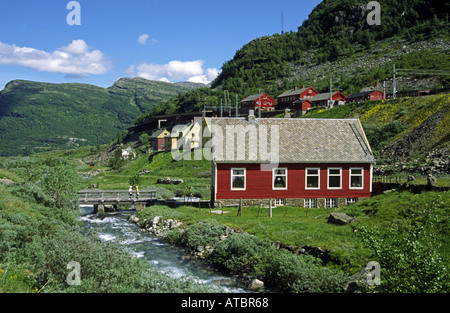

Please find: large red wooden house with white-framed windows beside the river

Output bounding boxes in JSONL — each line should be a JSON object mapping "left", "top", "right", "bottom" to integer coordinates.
{"left": 211, "top": 116, "right": 375, "bottom": 208}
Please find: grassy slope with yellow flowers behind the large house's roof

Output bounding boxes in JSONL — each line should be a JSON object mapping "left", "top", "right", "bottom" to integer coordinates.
{"left": 304, "top": 94, "right": 450, "bottom": 165}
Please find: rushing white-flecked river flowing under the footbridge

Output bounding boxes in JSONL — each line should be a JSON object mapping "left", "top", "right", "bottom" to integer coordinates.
{"left": 80, "top": 206, "right": 248, "bottom": 292}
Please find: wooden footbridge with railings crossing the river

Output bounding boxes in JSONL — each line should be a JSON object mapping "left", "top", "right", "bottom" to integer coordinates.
{"left": 78, "top": 189, "right": 156, "bottom": 213}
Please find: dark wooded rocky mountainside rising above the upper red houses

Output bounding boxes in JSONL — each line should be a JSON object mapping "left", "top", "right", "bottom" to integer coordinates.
{"left": 212, "top": 0, "right": 450, "bottom": 96}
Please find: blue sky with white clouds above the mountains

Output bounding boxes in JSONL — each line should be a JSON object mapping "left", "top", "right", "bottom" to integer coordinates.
{"left": 0, "top": 0, "right": 320, "bottom": 90}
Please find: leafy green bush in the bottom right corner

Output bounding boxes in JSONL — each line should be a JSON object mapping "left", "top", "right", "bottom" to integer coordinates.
{"left": 355, "top": 201, "right": 450, "bottom": 293}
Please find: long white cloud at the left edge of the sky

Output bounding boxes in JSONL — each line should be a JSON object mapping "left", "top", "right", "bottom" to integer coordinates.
{"left": 0, "top": 39, "right": 111, "bottom": 76}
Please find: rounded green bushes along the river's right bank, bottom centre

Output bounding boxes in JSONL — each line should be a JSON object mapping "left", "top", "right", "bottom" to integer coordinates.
{"left": 210, "top": 230, "right": 347, "bottom": 292}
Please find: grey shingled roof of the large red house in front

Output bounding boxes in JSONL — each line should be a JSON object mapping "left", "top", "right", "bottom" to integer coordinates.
{"left": 211, "top": 118, "right": 375, "bottom": 163}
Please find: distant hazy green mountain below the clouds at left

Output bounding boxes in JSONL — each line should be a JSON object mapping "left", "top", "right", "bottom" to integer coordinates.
{"left": 0, "top": 78, "right": 202, "bottom": 156}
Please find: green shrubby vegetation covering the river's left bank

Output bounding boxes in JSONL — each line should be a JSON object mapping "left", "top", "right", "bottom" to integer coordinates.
{"left": 0, "top": 157, "right": 215, "bottom": 293}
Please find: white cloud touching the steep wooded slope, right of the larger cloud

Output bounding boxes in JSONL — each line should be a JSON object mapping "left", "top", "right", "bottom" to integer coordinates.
{"left": 127, "top": 60, "right": 219, "bottom": 84}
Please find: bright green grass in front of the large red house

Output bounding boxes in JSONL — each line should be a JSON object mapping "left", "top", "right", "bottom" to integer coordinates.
{"left": 138, "top": 191, "right": 450, "bottom": 273}
